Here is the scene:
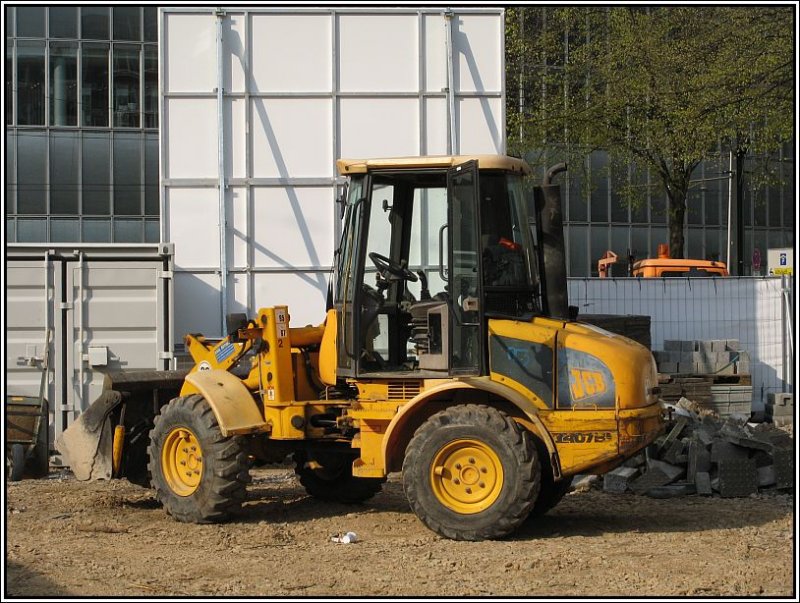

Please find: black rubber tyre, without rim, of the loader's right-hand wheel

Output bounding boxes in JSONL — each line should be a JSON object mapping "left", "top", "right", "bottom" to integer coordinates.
{"left": 403, "top": 404, "right": 541, "bottom": 541}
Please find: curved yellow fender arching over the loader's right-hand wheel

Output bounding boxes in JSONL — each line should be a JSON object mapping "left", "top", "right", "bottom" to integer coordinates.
{"left": 382, "top": 378, "right": 561, "bottom": 478}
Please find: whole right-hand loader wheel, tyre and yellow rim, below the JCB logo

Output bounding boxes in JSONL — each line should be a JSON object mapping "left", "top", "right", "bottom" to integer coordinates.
{"left": 403, "top": 404, "right": 540, "bottom": 540}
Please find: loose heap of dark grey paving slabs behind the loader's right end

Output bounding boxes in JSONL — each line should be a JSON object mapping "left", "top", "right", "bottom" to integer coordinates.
{"left": 603, "top": 413, "right": 794, "bottom": 498}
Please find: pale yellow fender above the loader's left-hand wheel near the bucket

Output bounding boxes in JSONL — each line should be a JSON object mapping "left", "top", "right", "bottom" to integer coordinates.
{"left": 184, "top": 370, "right": 268, "bottom": 437}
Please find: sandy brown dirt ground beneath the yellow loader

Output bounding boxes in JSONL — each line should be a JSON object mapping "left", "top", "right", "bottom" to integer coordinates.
{"left": 5, "top": 466, "right": 795, "bottom": 598}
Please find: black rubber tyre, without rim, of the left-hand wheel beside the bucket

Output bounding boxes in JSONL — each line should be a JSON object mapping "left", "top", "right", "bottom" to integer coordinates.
{"left": 148, "top": 394, "right": 250, "bottom": 523}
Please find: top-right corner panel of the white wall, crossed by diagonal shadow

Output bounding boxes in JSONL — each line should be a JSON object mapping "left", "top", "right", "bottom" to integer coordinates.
{"left": 453, "top": 14, "right": 505, "bottom": 92}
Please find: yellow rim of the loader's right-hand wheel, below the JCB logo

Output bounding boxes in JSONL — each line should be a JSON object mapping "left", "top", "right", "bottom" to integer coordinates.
{"left": 431, "top": 439, "right": 503, "bottom": 515}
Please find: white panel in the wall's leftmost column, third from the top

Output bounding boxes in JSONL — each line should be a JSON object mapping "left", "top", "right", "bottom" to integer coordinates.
{"left": 166, "top": 188, "right": 219, "bottom": 268}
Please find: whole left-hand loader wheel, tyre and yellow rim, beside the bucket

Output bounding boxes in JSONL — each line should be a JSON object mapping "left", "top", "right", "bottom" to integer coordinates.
{"left": 148, "top": 394, "right": 250, "bottom": 523}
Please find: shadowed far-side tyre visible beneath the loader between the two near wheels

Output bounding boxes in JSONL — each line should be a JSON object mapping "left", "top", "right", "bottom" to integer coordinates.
{"left": 294, "top": 451, "right": 386, "bottom": 504}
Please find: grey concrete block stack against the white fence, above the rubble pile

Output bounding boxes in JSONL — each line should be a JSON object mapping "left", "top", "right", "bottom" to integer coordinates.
{"left": 653, "top": 339, "right": 750, "bottom": 375}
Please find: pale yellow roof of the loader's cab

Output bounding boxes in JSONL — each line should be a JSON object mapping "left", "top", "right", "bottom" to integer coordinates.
{"left": 336, "top": 155, "right": 531, "bottom": 176}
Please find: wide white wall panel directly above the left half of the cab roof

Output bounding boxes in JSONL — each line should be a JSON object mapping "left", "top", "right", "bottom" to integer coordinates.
{"left": 339, "top": 98, "right": 419, "bottom": 158}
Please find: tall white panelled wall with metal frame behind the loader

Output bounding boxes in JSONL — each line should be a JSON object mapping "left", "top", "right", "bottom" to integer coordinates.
{"left": 159, "top": 7, "right": 505, "bottom": 341}
